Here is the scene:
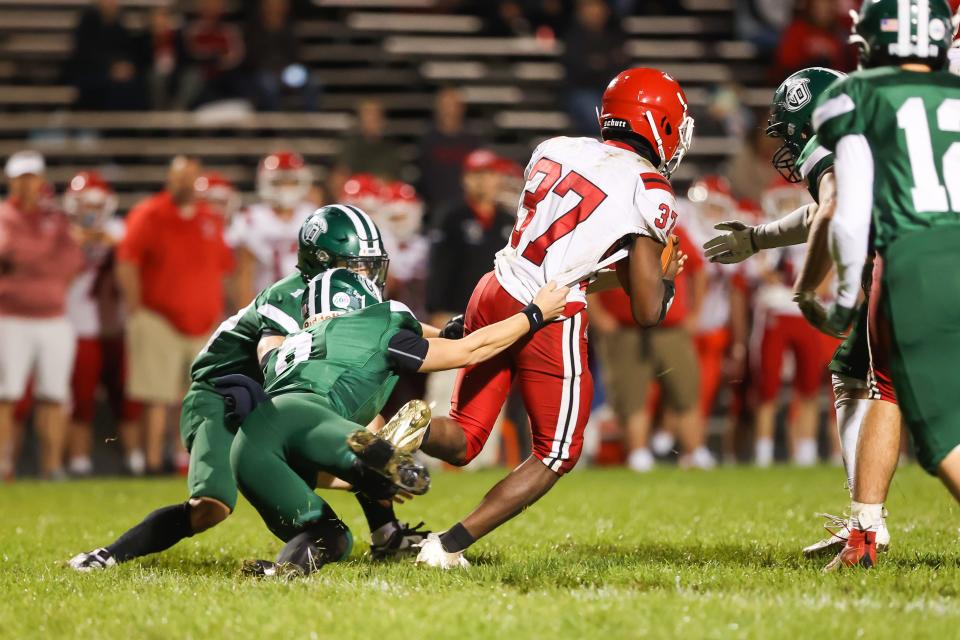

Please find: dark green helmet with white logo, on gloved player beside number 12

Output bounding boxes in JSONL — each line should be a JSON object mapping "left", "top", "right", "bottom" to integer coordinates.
{"left": 766, "top": 67, "right": 846, "bottom": 182}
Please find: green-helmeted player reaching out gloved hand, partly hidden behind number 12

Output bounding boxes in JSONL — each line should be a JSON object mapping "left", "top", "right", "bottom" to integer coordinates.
{"left": 704, "top": 67, "right": 900, "bottom": 556}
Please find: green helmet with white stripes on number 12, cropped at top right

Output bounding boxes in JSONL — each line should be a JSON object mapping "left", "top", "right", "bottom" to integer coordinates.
{"left": 850, "top": 0, "right": 955, "bottom": 69}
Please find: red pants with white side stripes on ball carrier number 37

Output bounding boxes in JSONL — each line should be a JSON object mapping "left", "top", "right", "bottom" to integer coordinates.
{"left": 450, "top": 272, "right": 593, "bottom": 475}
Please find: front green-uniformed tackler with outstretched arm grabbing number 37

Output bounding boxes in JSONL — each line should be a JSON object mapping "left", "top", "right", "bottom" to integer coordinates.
{"left": 230, "top": 269, "right": 569, "bottom": 575}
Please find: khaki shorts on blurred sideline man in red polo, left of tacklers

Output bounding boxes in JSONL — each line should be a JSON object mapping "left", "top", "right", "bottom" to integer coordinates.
{"left": 126, "top": 309, "right": 207, "bottom": 404}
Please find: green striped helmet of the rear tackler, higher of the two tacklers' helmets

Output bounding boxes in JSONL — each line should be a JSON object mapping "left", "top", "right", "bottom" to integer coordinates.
{"left": 297, "top": 204, "right": 390, "bottom": 287}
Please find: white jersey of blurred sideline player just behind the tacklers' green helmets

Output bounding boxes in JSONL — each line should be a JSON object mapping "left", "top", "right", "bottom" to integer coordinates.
{"left": 227, "top": 203, "right": 315, "bottom": 291}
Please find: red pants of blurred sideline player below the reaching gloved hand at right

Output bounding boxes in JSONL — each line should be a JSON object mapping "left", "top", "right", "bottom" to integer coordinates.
{"left": 756, "top": 314, "right": 837, "bottom": 404}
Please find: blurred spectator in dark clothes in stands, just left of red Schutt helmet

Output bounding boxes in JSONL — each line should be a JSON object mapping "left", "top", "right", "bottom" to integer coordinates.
{"left": 563, "top": 0, "right": 627, "bottom": 135}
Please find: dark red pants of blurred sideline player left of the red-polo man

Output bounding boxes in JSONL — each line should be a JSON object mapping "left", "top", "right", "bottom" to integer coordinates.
{"left": 71, "top": 337, "right": 140, "bottom": 422}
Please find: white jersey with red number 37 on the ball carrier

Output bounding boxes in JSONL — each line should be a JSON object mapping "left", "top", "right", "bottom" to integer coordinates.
{"left": 495, "top": 137, "right": 677, "bottom": 304}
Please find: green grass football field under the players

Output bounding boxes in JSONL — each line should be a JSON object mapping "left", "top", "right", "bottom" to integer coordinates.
{"left": 0, "top": 467, "right": 960, "bottom": 640}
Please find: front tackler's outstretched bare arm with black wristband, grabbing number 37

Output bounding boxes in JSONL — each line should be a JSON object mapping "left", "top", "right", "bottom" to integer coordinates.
{"left": 388, "top": 282, "right": 570, "bottom": 373}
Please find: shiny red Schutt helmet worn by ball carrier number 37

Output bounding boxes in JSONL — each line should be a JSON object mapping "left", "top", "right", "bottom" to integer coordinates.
{"left": 597, "top": 67, "right": 693, "bottom": 177}
